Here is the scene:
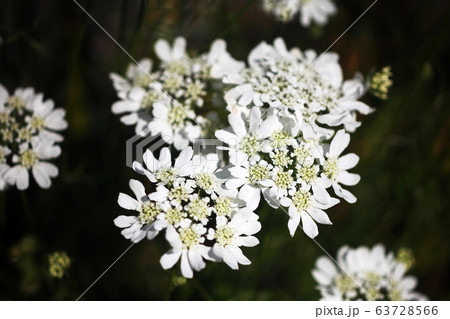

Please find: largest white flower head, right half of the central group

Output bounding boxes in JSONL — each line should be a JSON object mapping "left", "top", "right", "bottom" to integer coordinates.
{"left": 216, "top": 39, "right": 372, "bottom": 237}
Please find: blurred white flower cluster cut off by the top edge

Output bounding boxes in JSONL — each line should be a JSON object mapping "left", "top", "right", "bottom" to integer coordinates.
{"left": 263, "top": 0, "right": 336, "bottom": 27}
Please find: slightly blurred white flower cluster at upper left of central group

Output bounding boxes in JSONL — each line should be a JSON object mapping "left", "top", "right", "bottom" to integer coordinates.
{"left": 111, "top": 37, "right": 243, "bottom": 150}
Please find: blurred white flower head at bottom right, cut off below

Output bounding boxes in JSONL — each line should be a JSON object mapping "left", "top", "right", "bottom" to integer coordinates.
{"left": 312, "top": 244, "right": 427, "bottom": 301}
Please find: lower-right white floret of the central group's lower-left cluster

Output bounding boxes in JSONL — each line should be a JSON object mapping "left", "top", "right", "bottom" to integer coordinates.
{"left": 208, "top": 209, "right": 261, "bottom": 269}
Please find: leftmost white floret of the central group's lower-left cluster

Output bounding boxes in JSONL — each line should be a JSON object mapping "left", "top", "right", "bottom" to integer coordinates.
{"left": 114, "top": 179, "right": 165, "bottom": 243}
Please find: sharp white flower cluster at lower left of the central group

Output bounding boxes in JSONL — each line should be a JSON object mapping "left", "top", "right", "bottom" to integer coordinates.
{"left": 114, "top": 147, "right": 261, "bottom": 278}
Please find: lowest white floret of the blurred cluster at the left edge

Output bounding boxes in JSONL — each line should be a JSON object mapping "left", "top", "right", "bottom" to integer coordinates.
{"left": 4, "top": 139, "right": 61, "bottom": 190}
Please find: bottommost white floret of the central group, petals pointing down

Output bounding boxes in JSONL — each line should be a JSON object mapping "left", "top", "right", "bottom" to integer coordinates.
{"left": 160, "top": 224, "right": 211, "bottom": 278}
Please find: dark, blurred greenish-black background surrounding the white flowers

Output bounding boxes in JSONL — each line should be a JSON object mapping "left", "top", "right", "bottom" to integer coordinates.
{"left": 0, "top": 0, "right": 450, "bottom": 300}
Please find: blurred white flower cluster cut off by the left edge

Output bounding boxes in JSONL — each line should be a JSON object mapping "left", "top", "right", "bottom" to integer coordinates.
{"left": 0, "top": 85, "right": 67, "bottom": 190}
